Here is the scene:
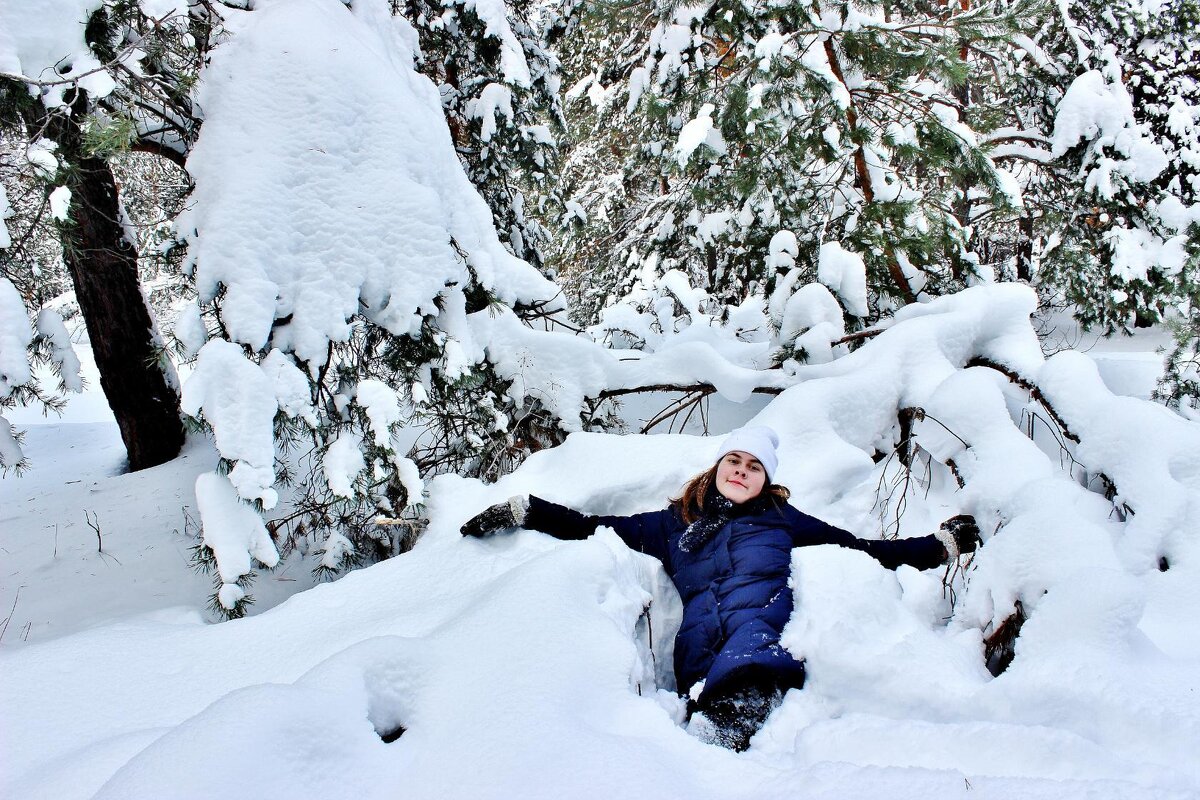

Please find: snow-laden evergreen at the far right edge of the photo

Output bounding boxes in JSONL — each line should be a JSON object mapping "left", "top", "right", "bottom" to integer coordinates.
{"left": 974, "top": 2, "right": 1200, "bottom": 412}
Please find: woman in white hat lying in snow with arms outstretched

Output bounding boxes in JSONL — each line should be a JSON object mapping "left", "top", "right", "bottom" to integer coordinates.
{"left": 462, "top": 427, "right": 979, "bottom": 751}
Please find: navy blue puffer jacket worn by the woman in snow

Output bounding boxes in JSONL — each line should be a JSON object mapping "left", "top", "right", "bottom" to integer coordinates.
{"left": 524, "top": 497, "right": 946, "bottom": 696}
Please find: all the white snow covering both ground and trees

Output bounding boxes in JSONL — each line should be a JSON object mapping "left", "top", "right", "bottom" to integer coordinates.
{"left": 0, "top": 0, "right": 1200, "bottom": 800}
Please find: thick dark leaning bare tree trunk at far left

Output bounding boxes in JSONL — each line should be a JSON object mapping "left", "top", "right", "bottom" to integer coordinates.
{"left": 47, "top": 91, "right": 184, "bottom": 470}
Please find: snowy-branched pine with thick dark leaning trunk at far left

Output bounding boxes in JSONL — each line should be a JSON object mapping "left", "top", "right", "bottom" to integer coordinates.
{"left": 0, "top": 0, "right": 220, "bottom": 469}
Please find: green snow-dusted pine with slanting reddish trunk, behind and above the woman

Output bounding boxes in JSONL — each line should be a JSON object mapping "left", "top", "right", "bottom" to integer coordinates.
{"left": 549, "top": 2, "right": 1037, "bottom": 328}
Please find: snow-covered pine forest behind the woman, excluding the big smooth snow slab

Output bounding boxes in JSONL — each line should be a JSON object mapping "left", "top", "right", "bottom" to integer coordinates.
{"left": 0, "top": 0, "right": 1200, "bottom": 615}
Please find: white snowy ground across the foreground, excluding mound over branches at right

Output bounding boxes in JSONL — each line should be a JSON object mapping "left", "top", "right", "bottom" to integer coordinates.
{"left": 0, "top": 303, "right": 1200, "bottom": 799}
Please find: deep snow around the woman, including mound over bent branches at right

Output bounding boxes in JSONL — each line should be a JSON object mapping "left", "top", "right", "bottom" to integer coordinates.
{"left": 0, "top": 284, "right": 1200, "bottom": 799}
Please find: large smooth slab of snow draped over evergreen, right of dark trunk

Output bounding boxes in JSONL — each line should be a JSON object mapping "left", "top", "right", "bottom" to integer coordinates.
{"left": 178, "top": 0, "right": 557, "bottom": 365}
